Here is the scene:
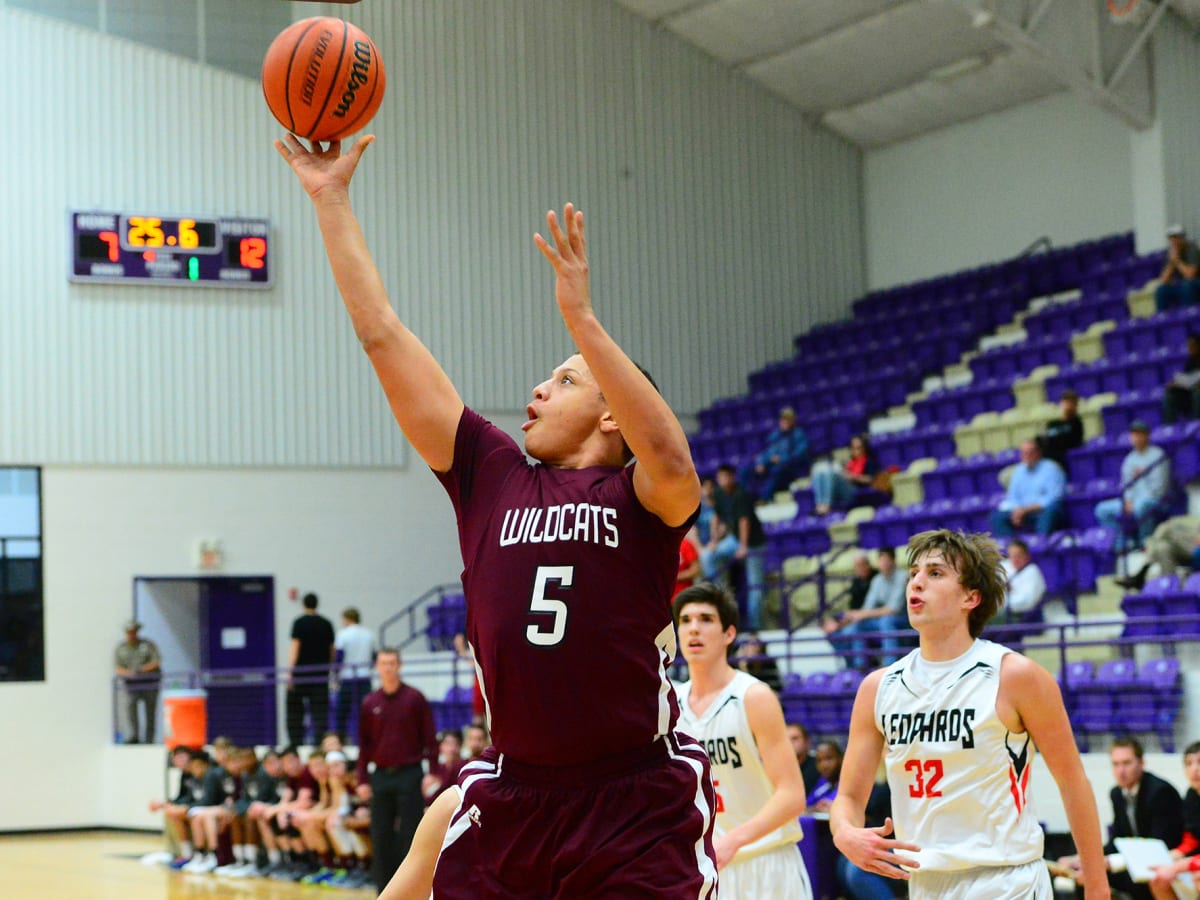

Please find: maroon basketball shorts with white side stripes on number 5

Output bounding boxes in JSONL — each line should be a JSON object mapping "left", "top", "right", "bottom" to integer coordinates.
{"left": 433, "top": 736, "right": 716, "bottom": 900}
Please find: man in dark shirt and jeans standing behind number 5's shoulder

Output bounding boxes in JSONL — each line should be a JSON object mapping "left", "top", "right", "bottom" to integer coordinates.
{"left": 700, "top": 463, "right": 767, "bottom": 630}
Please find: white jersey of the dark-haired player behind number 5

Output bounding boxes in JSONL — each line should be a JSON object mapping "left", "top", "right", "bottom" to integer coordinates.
{"left": 677, "top": 671, "right": 803, "bottom": 862}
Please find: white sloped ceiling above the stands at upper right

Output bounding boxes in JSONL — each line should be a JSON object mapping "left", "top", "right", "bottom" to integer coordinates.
{"left": 613, "top": 0, "right": 1171, "bottom": 148}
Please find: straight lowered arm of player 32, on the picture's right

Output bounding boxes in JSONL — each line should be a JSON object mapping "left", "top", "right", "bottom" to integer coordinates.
{"left": 1000, "top": 653, "right": 1110, "bottom": 900}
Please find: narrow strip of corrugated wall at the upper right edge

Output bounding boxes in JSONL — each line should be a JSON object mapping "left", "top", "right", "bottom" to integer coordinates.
{"left": 1153, "top": 14, "right": 1200, "bottom": 240}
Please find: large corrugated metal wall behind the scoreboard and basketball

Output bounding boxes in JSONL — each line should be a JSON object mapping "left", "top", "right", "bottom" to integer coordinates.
{"left": 0, "top": 7, "right": 864, "bottom": 466}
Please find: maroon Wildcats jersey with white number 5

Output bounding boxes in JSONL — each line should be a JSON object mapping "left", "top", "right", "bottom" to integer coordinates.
{"left": 438, "top": 409, "right": 690, "bottom": 766}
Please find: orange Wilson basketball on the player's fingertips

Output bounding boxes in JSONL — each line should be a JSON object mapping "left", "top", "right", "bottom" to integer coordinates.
{"left": 263, "top": 16, "right": 386, "bottom": 140}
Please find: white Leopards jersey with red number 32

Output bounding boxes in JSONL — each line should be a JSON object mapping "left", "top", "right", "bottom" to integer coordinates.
{"left": 875, "top": 640, "right": 1043, "bottom": 877}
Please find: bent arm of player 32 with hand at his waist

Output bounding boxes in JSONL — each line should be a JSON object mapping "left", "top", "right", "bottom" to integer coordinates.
{"left": 829, "top": 670, "right": 920, "bottom": 881}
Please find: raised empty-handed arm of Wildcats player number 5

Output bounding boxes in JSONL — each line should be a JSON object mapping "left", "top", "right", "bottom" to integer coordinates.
{"left": 533, "top": 203, "right": 700, "bottom": 526}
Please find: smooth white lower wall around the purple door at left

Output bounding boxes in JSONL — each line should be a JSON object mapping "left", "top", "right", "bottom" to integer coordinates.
{"left": 0, "top": 458, "right": 461, "bottom": 832}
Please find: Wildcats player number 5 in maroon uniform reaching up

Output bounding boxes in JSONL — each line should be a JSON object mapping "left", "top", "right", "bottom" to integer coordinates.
{"left": 276, "top": 134, "right": 716, "bottom": 900}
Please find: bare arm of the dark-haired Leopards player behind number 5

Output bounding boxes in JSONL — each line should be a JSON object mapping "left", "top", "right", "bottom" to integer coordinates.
{"left": 713, "top": 684, "right": 804, "bottom": 869}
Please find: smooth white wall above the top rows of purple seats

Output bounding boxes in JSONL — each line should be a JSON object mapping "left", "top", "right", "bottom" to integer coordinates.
{"left": 864, "top": 94, "right": 1132, "bottom": 288}
